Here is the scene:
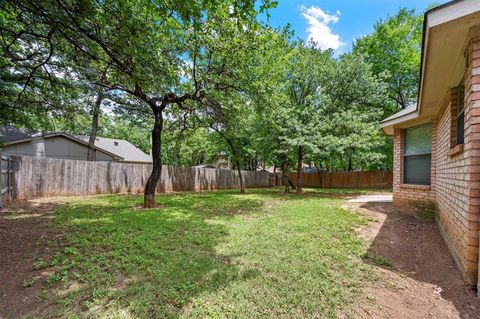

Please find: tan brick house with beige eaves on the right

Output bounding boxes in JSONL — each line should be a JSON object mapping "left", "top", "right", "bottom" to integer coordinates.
{"left": 381, "top": 0, "right": 480, "bottom": 288}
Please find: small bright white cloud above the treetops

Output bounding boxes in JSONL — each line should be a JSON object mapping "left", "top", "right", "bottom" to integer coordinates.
{"left": 300, "top": 6, "right": 345, "bottom": 50}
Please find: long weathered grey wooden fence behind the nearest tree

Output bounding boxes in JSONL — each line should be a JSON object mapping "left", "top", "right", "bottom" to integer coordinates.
{"left": 12, "top": 156, "right": 270, "bottom": 199}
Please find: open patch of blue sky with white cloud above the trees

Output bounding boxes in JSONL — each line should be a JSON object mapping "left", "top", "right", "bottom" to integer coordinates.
{"left": 260, "top": 0, "right": 447, "bottom": 53}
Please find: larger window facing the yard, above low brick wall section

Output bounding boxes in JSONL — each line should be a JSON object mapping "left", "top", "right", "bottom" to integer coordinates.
{"left": 403, "top": 124, "right": 432, "bottom": 185}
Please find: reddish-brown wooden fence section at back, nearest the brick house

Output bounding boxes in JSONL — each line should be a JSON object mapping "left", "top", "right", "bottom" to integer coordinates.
{"left": 289, "top": 171, "right": 393, "bottom": 188}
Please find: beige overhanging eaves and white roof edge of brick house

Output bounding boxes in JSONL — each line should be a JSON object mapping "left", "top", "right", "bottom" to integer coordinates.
{"left": 380, "top": 0, "right": 480, "bottom": 135}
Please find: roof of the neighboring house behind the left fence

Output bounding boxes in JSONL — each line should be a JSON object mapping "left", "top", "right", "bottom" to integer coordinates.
{"left": 0, "top": 126, "right": 152, "bottom": 163}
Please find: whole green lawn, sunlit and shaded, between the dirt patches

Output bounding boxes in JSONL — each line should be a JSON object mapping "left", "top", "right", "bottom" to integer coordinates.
{"left": 44, "top": 189, "right": 378, "bottom": 318}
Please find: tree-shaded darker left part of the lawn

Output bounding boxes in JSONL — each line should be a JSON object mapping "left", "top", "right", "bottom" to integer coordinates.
{"left": 46, "top": 193, "right": 259, "bottom": 318}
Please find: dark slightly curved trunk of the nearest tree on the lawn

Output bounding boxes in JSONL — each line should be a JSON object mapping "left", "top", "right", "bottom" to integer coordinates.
{"left": 143, "top": 105, "right": 163, "bottom": 208}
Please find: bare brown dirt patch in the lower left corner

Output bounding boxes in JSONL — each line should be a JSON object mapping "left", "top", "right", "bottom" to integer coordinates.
{"left": 0, "top": 200, "right": 61, "bottom": 318}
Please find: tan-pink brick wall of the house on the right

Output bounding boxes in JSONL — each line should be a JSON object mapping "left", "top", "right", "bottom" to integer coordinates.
{"left": 393, "top": 37, "right": 480, "bottom": 284}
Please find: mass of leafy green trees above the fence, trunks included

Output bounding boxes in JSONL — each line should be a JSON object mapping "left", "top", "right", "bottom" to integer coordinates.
{"left": 0, "top": 0, "right": 428, "bottom": 198}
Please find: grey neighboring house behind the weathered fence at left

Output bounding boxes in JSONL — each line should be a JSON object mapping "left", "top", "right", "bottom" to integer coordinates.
{"left": 0, "top": 126, "right": 152, "bottom": 163}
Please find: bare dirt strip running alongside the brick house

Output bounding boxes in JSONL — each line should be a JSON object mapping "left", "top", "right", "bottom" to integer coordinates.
{"left": 347, "top": 203, "right": 480, "bottom": 318}
